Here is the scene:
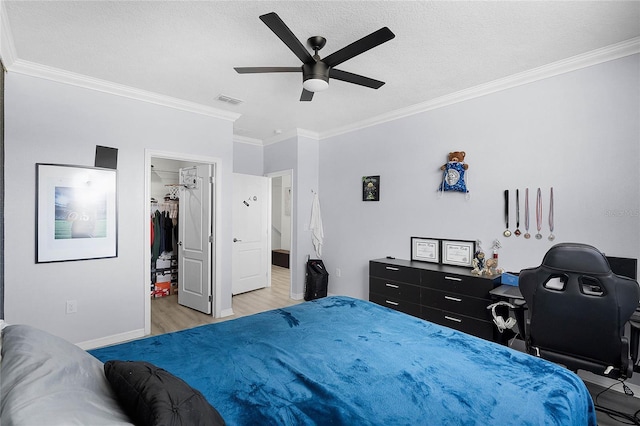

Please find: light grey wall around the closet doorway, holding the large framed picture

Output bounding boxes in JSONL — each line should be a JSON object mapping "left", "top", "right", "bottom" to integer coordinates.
{"left": 4, "top": 73, "right": 233, "bottom": 343}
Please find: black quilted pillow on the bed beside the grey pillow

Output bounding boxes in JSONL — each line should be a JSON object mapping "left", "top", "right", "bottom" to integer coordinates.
{"left": 104, "top": 361, "right": 225, "bottom": 426}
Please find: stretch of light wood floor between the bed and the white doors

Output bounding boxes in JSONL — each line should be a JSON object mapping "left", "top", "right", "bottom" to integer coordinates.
{"left": 151, "top": 265, "right": 301, "bottom": 335}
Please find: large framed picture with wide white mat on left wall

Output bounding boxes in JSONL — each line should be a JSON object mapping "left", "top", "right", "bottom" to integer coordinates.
{"left": 35, "top": 163, "right": 118, "bottom": 263}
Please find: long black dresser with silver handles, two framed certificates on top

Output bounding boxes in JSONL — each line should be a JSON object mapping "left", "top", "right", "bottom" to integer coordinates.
{"left": 369, "top": 258, "right": 500, "bottom": 340}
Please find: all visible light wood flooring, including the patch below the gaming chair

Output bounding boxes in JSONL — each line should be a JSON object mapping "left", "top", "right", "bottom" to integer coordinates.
{"left": 151, "top": 266, "right": 640, "bottom": 426}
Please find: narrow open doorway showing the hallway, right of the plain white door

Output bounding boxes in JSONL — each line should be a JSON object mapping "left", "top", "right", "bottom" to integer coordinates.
{"left": 267, "top": 170, "right": 295, "bottom": 298}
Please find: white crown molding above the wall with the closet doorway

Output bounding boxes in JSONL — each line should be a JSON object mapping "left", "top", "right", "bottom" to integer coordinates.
{"left": 7, "top": 59, "right": 240, "bottom": 121}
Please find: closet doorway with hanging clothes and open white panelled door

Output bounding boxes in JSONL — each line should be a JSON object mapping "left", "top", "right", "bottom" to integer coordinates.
{"left": 145, "top": 151, "right": 220, "bottom": 334}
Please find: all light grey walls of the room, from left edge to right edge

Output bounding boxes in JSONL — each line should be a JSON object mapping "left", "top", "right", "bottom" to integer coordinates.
{"left": 5, "top": 55, "right": 640, "bottom": 342}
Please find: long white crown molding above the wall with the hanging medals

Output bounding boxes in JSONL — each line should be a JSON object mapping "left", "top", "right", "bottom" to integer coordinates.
{"left": 319, "top": 37, "right": 640, "bottom": 140}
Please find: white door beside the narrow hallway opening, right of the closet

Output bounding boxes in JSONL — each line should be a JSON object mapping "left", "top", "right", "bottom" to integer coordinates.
{"left": 231, "top": 173, "right": 271, "bottom": 294}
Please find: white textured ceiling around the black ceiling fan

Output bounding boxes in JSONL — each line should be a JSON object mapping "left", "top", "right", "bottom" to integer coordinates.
{"left": 3, "top": 0, "right": 640, "bottom": 141}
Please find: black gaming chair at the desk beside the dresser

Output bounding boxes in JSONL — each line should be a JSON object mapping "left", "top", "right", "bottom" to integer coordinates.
{"left": 519, "top": 243, "right": 640, "bottom": 379}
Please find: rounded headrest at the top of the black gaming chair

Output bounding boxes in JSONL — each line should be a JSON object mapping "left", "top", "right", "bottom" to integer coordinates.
{"left": 542, "top": 243, "right": 611, "bottom": 274}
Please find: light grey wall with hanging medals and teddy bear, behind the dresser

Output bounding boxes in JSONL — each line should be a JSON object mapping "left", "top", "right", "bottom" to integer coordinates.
{"left": 320, "top": 55, "right": 640, "bottom": 299}
